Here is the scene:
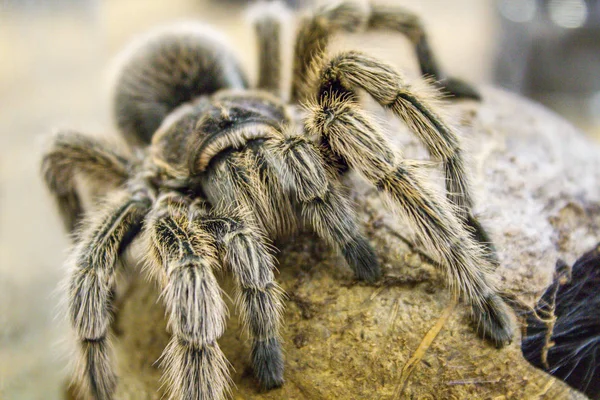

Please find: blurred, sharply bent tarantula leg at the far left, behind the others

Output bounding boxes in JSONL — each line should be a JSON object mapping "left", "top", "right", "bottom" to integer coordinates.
{"left": 41, "top": 131, "right": 130, "bottom": 232}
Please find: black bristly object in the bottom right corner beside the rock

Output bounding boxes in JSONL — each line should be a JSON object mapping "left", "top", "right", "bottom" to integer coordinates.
{"left": 521, "top": 243, "right": 600, "bottom": 399}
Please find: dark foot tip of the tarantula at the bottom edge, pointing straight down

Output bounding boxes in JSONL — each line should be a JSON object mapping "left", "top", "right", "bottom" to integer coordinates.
{"left": 252, "top": 338, "right": 284, "bottom": 390}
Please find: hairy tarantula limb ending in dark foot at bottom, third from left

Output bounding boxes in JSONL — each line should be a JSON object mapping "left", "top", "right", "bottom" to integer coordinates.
{"left": 194, "top": 202, "right": 284, "bottom": 389}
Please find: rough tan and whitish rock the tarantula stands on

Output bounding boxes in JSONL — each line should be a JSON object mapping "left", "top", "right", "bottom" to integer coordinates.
{"left": 69, "top": 89, "right": 600, "bottom": 399}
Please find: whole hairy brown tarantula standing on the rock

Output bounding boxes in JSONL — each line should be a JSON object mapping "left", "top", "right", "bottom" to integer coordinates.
{"left": 42, "top": 1, "right": 512, "bottom": 399}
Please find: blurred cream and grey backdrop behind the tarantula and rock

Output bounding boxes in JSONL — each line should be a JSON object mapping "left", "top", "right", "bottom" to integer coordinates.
{"left": 0, "top": 0, "right": 600, "bottom": 399}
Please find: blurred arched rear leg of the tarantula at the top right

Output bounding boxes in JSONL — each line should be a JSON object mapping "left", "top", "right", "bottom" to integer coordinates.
{"left": 292, "top": 0, "right": 480, "bottom": 101}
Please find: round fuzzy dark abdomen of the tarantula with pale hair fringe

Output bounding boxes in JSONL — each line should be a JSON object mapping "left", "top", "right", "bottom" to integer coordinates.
{"left": 114, "top": 25, "right": 248, "bottom": 146}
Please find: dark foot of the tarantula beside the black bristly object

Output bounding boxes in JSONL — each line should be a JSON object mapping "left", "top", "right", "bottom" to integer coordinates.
{"left": 473, "top": 293, "right": 513, "bottom": 348}
